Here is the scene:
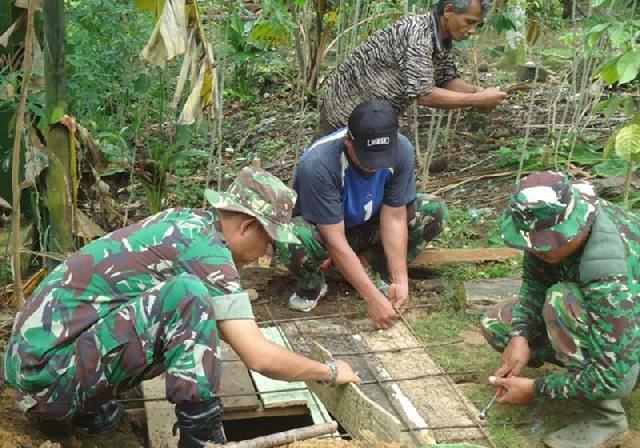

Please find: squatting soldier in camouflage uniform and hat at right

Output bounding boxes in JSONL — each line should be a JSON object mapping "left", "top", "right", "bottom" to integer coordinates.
{"left": 482, "top": 171, "right": 640, "bottom": 448}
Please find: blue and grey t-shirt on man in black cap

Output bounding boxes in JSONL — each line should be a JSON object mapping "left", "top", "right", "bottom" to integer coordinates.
{"left": 293, "top": 128, "right": 416, "bottom": 229}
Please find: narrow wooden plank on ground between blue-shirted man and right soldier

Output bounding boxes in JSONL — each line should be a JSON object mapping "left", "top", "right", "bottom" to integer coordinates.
{"left": 411, "top": 247, "right": 522, "bottom": 268}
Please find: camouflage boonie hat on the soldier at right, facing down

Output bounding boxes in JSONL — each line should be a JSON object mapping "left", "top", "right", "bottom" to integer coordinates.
{"left": 500, "top": 171, "right": 597, "bottom": 252}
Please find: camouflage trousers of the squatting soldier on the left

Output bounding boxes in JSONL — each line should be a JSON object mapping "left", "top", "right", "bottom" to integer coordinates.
{"left": 19, "top": 274, "right": 220, "bottom": 420}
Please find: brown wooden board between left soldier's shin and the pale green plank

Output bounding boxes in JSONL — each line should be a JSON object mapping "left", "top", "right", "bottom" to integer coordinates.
{"left": 219, "top": 342, "right": 260, "bottom": 412}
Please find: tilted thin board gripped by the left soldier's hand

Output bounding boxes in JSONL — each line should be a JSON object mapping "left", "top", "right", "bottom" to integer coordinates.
{"left": 307, "top": 342, "right": 402, "bottom": 442}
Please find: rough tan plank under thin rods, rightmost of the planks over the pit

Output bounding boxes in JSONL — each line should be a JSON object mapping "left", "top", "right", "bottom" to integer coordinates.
{"left": 360, "top": 323, "right": 484, "bottom": 443}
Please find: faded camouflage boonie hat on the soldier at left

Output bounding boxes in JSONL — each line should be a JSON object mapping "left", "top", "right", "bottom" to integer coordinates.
{"left": 204, "top": 167, "right": 300, "bottom": 244}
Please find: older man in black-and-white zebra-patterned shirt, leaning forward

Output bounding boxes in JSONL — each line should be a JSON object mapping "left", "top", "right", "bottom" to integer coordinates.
{"left": 316, "top": 0, "right": 506, "bottom": 138}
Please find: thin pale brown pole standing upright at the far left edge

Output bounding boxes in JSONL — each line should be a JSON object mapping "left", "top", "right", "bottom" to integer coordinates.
{"left": 11, "top": 0, "right": 35, "bottom": 307}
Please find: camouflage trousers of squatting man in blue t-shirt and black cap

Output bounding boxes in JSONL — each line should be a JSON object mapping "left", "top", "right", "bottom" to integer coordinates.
{"left": 276, "top": 194, "right": 448, "bottom": 297}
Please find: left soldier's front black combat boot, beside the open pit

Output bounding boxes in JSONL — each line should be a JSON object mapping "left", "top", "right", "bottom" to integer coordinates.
{"left": 174, "top": 398, "right": 227, "bottom": 448}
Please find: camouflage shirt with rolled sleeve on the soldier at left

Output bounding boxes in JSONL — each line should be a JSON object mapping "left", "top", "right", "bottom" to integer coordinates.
{"left": 5, "top": 209, "right": 253, "bottom": 391}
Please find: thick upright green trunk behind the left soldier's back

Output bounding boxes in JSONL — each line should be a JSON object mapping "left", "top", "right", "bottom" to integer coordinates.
{"left": 43, "top": 0, "right": 74, "bottom": 263}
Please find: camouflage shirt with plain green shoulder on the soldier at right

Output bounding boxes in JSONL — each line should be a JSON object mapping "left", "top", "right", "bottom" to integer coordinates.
{"left": 511, "top": 199, "right": 640, "bottom": 400}
